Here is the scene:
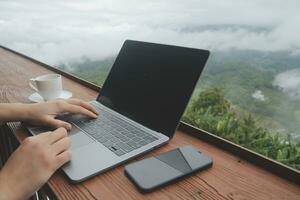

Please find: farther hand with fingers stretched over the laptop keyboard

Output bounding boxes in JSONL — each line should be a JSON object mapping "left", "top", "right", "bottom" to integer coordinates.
{"left": 27, "top": 99, "right": 98, "bottom": 130}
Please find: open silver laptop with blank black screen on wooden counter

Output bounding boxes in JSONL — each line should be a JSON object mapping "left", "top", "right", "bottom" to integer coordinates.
{"left": 27, "top": 40, "right": 209, "bottom": 182}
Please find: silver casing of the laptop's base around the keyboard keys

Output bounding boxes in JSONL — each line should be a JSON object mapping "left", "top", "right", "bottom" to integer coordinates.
{"left": 27, "top": 101, "right": 169, "bottom": 182}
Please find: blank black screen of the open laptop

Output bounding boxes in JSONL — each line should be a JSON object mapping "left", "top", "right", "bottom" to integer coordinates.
{"left": 97, "top": 40, "right": 209, "bottom": 138}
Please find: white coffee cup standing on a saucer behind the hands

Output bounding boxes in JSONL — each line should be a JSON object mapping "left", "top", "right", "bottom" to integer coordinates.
{"left": 29, "top": 74, "right": 63, "bottom": 101}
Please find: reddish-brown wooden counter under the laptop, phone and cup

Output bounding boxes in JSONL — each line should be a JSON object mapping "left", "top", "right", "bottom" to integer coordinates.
{"left": 0, "top": 48, "right": 300, "bottom": 200}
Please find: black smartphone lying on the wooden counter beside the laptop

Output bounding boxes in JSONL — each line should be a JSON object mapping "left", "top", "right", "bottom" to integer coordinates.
{"left": 125, "top": 145, "right": 213, "bottom": 192}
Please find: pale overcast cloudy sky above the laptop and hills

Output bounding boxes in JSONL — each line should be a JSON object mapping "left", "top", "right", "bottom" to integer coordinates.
{"left": 0, "top": 0, "right": 300, "bottom": 65}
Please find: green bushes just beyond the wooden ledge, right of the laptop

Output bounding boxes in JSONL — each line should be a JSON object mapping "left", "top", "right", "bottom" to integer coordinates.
{"left": 183, "top": 88, "right": 300, "bottom": 170}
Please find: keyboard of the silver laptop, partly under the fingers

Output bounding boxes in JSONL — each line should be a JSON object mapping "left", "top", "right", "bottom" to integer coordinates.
{"left": 72, "top": 105, "right": 158, "bottom": 156}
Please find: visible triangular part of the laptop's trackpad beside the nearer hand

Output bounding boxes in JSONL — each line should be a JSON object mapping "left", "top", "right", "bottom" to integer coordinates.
{"left": 70, "top": 127, "right": 95, "bottom": 150}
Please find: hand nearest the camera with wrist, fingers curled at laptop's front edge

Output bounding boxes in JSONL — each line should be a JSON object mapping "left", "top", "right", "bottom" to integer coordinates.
{"left": 0, "top": 128, "right": 71, "bottom": 200}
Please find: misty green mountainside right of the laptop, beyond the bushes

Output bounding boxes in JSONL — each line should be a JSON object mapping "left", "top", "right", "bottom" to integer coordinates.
{"left": 198, "top": 50, "right": 300, "bottom": 140}
